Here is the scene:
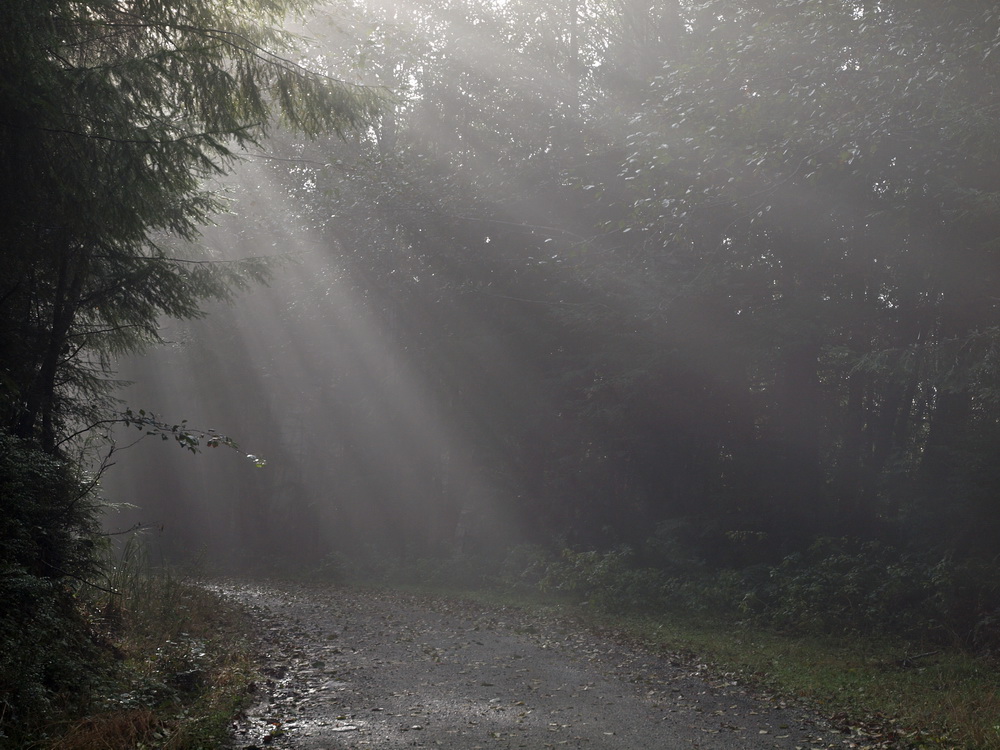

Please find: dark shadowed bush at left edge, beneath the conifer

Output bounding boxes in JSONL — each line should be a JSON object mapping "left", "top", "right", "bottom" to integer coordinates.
{"left": 0, "top": 433, "right": 106, "bottom": 745}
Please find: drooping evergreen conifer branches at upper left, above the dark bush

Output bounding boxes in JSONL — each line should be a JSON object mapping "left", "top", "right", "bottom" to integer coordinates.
{"left": 0, "top": 0, "right": 375, "bottom": 452}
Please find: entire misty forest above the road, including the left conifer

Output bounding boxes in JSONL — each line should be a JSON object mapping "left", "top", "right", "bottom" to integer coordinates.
{"left": 0, "top": 0, "right": 1000, "bottom": 748}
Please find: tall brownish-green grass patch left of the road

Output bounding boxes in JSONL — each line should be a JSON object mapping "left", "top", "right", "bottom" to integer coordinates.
{"left": 39, "top": 544, "right": 256, "bottom": 750}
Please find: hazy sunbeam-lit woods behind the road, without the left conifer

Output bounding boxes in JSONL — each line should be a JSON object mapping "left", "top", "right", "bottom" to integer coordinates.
{"left": 104, "top": 0, "right": 998, "bottom": 569}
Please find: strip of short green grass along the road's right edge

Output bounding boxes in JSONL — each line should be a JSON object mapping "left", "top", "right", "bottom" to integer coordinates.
{"left": 372, "top": 584, "right": 1000, "bottom": 750}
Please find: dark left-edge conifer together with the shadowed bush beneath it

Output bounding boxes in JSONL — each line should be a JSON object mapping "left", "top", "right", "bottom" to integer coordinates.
{"left": 0, "top": 0, "right": 377, "bottom": 741}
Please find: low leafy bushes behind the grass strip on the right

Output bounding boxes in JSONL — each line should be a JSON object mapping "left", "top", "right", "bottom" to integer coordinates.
{"left": 497, "top": 535, "right": 1000, "bottom": 654}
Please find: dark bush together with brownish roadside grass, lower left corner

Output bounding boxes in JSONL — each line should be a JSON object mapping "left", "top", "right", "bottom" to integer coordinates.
{"left": 0, "top": 430, "right": 253, "bottom": 750}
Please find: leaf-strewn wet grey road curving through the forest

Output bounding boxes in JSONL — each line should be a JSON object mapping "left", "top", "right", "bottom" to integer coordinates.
{"left": 219, "top": 583, "right": 859, "bottom": 750}
